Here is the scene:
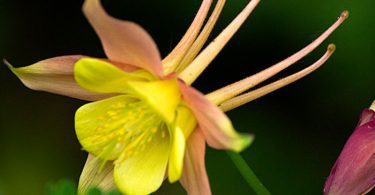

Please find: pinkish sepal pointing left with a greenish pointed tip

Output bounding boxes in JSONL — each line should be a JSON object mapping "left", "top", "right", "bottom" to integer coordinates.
{"left": 7, "top": 55, "right": 112, "bottom": 101}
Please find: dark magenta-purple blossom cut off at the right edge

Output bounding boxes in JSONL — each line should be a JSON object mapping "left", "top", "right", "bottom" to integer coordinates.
{"left": 324, "top": 101, "right": 375, "bottom": 195}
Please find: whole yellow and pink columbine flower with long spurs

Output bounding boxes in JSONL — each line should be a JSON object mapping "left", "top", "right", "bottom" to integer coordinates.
{"left": 8, "top": 0, "right": 347, "bottom": 194}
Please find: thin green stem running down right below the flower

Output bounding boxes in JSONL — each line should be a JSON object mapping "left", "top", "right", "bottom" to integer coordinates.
{"left": 227, "top": 151, "right": 271, "bottom": 195}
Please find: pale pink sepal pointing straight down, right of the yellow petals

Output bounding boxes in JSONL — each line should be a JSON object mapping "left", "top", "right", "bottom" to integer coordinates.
{"left": 180, "top": 128, "right": 211, "bottom": 195}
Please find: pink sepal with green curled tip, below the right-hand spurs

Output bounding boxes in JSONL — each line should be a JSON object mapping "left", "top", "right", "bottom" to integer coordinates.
{"left": 179, "top": 81, "right": 252, "bottom": 152}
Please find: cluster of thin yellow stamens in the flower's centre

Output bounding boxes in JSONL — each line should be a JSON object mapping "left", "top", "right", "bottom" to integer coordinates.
{"left": 96, "top": 99, "right": 168, "bottom": 161}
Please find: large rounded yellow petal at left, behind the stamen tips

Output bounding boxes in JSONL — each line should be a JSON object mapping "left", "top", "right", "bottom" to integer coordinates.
{"left": 75, "top": 95, "right": 136, "bottom": 160}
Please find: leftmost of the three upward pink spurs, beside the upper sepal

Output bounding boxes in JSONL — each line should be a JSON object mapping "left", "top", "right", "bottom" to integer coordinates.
{"left": 162, "top": 0, "right": 212, "bottom": 74}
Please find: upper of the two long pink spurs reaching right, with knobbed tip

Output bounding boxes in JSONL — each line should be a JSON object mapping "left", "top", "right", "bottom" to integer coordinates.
{"left": 206, "top": 11, "right": 349, "bottom": 105}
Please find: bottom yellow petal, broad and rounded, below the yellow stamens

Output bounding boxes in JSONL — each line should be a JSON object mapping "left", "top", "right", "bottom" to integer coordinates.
{"left": 113, "top": 133, "right": 170, "bottom": 195}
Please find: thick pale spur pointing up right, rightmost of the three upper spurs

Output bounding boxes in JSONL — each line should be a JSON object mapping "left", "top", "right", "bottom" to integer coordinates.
{"left": 179, "top": 0, "right": 259, "bottom": 84}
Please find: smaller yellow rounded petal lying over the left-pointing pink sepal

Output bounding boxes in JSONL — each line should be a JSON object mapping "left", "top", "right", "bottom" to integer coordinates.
{"left": 74, "top": 58, "right": 152, "bottom": 93}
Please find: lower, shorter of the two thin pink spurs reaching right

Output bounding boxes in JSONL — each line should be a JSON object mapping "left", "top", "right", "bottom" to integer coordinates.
{"left": 219, "top": 44, "right": 335, "bottom": 112}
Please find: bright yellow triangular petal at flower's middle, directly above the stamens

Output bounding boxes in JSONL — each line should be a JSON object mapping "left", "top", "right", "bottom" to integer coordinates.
{"left": 128, "top": 79, "right": 181, "bottom": 123}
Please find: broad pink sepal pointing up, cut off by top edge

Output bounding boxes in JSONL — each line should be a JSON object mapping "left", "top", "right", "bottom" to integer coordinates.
{"left": 83, "top": 0, "right": 163, "bottom": 77}
